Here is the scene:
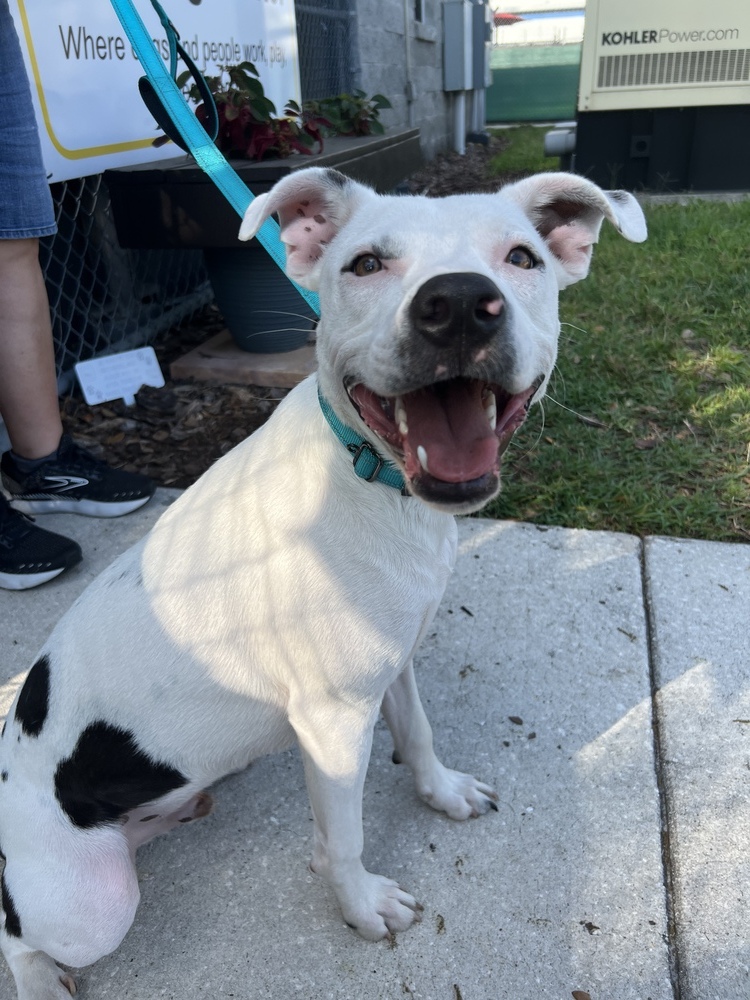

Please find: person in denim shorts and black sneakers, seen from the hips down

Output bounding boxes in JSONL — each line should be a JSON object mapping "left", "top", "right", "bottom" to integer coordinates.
{"left": 0, "top": 0, "right": 154, "bottom": 590}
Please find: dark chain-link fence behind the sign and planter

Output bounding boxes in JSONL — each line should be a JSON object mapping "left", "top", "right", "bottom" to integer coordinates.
{"left": 40, "top": 0, "right": 358, "bottom": 391}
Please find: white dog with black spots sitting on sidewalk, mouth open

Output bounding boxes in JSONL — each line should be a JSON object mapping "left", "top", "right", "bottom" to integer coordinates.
{"left": 0, "top": 169, "right": 646, "bottom": 1000}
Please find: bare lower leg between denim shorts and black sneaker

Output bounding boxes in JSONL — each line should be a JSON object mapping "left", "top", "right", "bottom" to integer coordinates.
{"left": 0, "top": 239, "right": 63, "bottom": 459}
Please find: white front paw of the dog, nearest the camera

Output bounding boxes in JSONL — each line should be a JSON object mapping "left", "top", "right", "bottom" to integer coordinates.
{"left": 334, "top": 870, "right": 423, "bottom": 941}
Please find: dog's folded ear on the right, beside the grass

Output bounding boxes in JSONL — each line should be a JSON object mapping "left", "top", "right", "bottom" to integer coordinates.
{"left": 502, "top": 173, "right": 646, "bottom": 288}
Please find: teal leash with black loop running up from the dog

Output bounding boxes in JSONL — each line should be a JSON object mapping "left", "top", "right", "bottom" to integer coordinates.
{"left": 111, "top": 0, "right": 320, "bottom": 316}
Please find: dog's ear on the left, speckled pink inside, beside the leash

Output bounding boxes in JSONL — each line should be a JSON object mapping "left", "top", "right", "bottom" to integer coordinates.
{"left": 239, "top": 167, "right": 377, "bottom": 290}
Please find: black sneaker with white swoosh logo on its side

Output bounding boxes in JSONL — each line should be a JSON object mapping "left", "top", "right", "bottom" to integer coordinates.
{"left": 0, "top": 434, "right": 155, "bottom": 517}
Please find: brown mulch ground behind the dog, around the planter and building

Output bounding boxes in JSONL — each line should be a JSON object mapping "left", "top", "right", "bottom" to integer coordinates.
{"left": 62, "top": 138, "right": 524, "bottom": 489}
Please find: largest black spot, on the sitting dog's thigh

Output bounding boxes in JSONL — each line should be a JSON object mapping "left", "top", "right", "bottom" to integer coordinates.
{"left": 55, "top": 722, "right": 187, "bottom": 829}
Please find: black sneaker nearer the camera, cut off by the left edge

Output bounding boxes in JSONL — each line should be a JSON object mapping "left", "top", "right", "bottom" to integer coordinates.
{"left": 0, "top": 493, "right": 83, "bottom": 590}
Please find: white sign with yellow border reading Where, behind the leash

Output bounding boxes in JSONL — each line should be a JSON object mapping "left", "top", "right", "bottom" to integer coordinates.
{"left": 10, "top": 0, "right": 300, "bottom": 181}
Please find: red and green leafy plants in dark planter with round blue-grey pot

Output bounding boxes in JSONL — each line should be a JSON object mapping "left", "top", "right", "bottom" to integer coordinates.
{"left": 105, "top": 70, "right": 423, "bottom": 352}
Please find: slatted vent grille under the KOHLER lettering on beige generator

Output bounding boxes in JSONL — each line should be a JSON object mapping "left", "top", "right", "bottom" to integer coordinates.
{"left": 597, "top": 49, "right": 750, "bottom": 90}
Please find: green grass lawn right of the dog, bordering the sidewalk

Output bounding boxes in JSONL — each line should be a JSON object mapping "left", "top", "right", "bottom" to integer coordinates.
{"left": 486, "top": 130, "right": 750, "bottom": 541}
